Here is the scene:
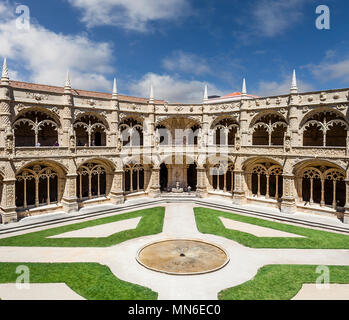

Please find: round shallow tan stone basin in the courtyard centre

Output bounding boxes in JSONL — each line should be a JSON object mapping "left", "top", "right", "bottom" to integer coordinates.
{"left": 137, "top": 239, "right": 229, "bottom": 275}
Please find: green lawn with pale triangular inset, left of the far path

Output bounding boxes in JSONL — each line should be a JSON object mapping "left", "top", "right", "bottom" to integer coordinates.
{"left": 0, "top": 207, "right": 165, "bottom": 247}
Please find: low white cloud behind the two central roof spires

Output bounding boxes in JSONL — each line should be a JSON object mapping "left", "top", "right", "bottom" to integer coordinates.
{"left": 130, "top": 73, "right": 222, "bottom": 103}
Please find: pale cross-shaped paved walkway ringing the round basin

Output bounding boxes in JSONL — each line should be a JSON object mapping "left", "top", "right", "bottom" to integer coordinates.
{"left": 0, "top": 203, "right": 349, "bottom": 300}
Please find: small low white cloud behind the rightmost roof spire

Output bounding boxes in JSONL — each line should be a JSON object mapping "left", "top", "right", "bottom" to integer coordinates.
{"left": 256, "top": 78, "right": 314, "bottom": 97}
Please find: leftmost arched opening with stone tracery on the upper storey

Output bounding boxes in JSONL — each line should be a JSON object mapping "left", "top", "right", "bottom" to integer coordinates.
{"left": 13, "top": 111, "right": 58, "bottom": 147}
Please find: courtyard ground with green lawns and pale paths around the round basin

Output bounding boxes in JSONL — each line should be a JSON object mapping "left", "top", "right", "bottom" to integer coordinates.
{"left": 0, "top": 199, "right": 349, "bottom": 300}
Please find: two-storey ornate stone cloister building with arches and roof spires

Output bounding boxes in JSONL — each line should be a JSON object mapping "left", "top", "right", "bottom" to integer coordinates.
{"left": 0, "top": 60, "right": 349, "bottom": 223}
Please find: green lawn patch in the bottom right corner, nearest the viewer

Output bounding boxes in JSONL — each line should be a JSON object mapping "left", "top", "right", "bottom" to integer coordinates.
{"left": 218, "top": 265, "right": 349, "bottom": 300}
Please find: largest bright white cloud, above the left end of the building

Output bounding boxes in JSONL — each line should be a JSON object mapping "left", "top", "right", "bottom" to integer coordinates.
{"left": 0, "top": 2, "right": 114, "bottom": 90}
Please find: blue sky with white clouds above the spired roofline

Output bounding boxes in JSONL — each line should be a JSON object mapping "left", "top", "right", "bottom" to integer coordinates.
{"left": 0, "top": 0, "right": 349, "bottom": 102}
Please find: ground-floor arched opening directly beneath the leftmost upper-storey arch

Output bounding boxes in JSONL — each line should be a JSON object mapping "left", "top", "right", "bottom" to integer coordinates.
{"left": 16, "top": 165, "right": 58, "bottom": 209}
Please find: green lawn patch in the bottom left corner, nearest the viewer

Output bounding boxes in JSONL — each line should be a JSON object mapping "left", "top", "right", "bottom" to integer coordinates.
{"left": 0, "top": 263, "right": 158, "bottom": 300}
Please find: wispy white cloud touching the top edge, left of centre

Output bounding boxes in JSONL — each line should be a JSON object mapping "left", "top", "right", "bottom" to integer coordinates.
{"left": 68, "top": 0, "right": 190, "bottom": 32}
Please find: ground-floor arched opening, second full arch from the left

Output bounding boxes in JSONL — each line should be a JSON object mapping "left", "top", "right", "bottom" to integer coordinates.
{"left": 76, "top": 162, "right": 107, "bottom": 201}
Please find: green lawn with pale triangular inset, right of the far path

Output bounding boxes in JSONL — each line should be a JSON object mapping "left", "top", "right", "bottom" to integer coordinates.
{"left": 194, "top": 208, "right": 349, "bottom": 249}
